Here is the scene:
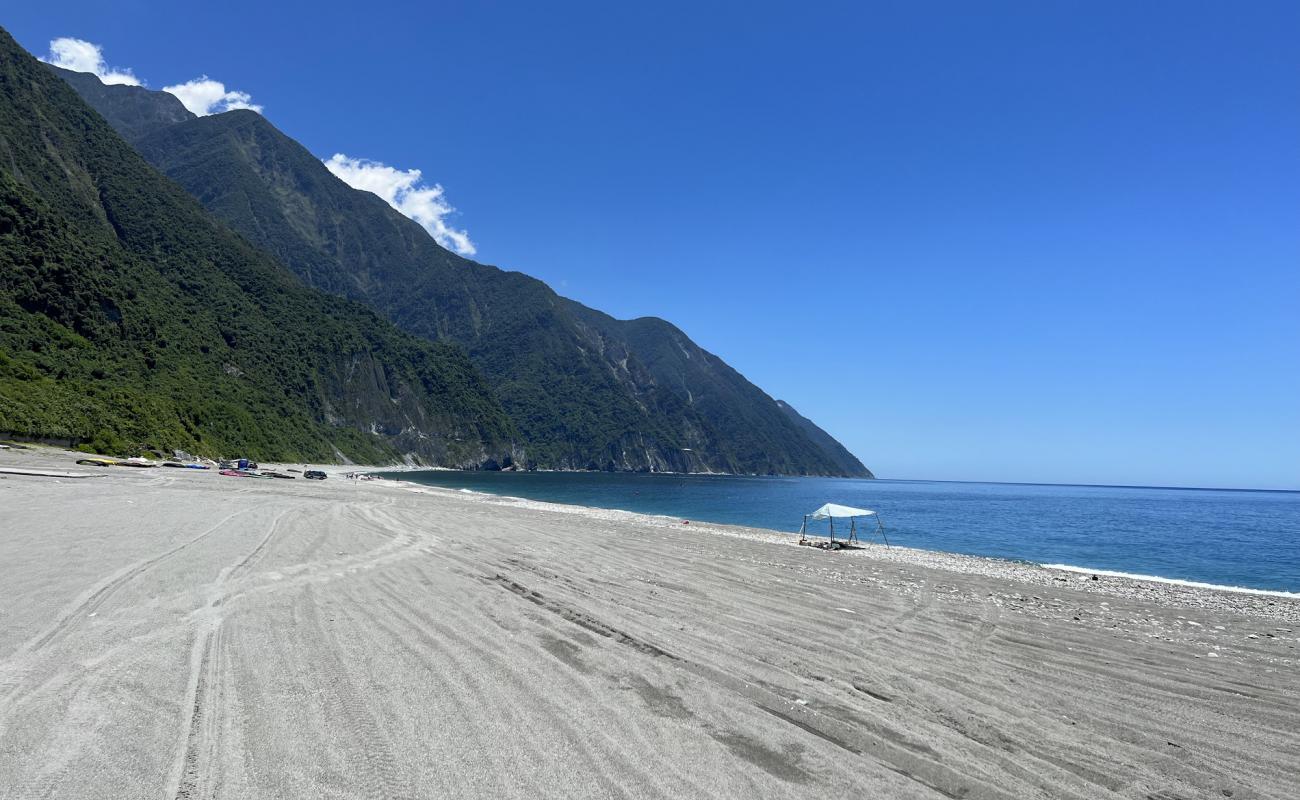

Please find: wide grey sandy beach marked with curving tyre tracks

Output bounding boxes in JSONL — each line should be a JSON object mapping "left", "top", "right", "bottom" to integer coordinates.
{"left": 0, "top": 449, "right": 1300, "bottom": 800}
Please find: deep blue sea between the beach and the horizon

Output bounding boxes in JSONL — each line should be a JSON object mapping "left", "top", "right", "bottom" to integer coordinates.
{"left": 387, "top": 471, "right": 1300, "bottom": 592}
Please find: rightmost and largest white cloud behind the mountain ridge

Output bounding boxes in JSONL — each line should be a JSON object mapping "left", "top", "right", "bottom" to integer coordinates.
{"left": 325, "top": 152, "right": 477, "bottom": 255}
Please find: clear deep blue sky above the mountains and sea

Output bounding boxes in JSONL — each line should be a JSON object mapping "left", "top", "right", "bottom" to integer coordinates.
{"left": 0, "top": 0, "right": 1300, "bottom": 488}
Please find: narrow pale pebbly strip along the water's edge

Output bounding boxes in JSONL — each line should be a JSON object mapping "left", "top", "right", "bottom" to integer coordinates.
{"left": 374, "top": 475, "right": 1300, "bottom": 611}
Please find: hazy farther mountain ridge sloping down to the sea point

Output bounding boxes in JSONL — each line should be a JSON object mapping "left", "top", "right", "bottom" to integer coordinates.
{"left": 48, "top": 62, "right": 870, "bottom": 476}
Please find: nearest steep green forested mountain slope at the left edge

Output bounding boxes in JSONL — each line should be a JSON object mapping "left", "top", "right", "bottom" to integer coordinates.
{"left": 0, "top": 30, "right": 517, "bottom": 466}
